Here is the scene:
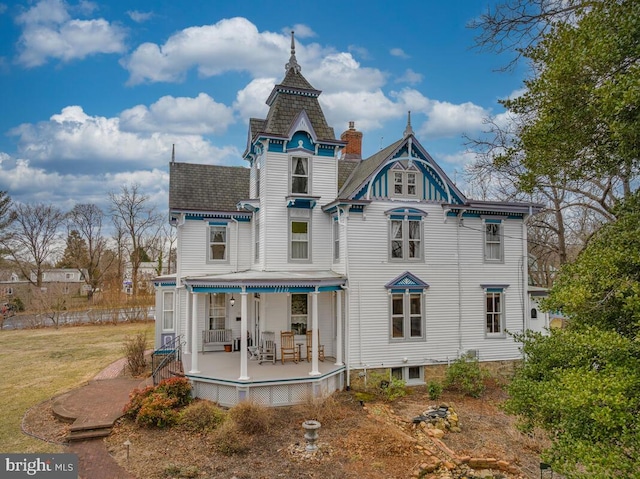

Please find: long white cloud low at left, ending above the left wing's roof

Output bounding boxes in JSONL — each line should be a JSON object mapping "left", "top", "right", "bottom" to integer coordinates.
{"left": 9, "top": 106, "right": 240, "bottom": 173}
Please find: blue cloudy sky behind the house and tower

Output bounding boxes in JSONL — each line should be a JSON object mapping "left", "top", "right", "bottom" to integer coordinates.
{"left": 0, "top": 0, "right": 523, "bottom": 216}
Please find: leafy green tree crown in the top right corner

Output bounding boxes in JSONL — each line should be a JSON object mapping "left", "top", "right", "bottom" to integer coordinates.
{"left": 504, "top": 0, "right": 640, "bottom": 197}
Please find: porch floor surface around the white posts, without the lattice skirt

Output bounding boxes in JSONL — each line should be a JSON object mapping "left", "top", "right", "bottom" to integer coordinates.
{"left": 182, "top": 351, "right": 344, "bottom": 384}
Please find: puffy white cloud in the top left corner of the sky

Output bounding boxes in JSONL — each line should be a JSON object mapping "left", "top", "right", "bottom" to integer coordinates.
{"left": 16, "top": 0, "right": 125, "bottom": 67}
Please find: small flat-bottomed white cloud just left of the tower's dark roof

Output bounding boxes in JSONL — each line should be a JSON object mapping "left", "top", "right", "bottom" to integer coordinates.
{"left": 120, "top": 93, "right": 234, "bottom": 135}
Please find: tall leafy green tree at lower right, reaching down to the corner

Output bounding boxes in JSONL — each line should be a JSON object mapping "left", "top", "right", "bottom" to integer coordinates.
{"left": 506, "top": 192, "right": 640, "bottom": 478}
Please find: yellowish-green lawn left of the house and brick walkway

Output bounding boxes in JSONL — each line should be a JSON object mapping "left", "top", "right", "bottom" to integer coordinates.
{"left": 0, "top": 322, "right": 153, "bottom": 453}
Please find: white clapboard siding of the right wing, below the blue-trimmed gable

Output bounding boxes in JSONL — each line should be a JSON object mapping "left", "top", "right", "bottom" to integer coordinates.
{"left": 347, "top": 202, "right": 523, "bottom": 367}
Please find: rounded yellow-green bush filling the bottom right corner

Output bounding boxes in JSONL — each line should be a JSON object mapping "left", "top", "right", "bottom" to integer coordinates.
{"left": 506, "top": 326, "right": 640, "bottom": 479}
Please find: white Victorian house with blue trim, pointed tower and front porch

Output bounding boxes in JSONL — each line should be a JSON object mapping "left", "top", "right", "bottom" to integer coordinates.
{"left": 155, "top": 34, "right": 541, "bottom": 405}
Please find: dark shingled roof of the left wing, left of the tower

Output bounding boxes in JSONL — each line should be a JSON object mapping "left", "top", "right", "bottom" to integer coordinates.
{"left": 169, "top": 163, "right": 250, "bottom": 211}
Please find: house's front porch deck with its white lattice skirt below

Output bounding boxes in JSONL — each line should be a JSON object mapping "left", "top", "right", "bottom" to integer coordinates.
{"left": 183, "top": 352, "right": 345, "bottom": 407}
